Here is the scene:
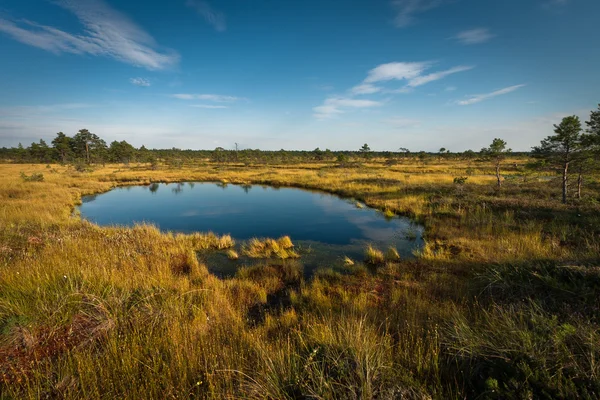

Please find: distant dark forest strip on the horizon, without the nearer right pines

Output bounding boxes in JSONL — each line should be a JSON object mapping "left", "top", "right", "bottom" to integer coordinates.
{"left": 0, "top": 129, "right": 529, "bottom": 164}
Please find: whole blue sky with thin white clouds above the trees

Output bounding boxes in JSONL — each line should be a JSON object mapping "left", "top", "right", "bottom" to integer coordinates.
{"left": 0, "top": 0, "right": 600, "bottom": 151}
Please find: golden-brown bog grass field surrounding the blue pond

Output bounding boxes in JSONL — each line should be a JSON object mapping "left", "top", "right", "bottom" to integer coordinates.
{"left": 0, "top": 159, "right": 600, "bottom": 399}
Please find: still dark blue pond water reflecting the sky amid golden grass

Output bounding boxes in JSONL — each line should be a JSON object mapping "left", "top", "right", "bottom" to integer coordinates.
{"left": 79, "top": 182, "right": 423, "bottom": 276}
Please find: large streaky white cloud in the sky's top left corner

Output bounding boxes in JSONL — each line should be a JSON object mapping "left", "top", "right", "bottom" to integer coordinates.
{"left": 0, "top": 0, "right": 179, "bottom": 70}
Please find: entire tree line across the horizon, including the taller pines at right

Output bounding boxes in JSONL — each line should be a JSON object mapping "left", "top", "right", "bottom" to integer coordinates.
{"left": 0, "top": 105, "right": 600, "bottom": 203}
